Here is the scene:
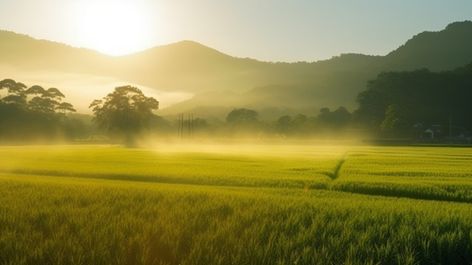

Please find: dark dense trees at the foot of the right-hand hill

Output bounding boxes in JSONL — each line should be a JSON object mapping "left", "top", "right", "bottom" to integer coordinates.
{"left": 355, "top": 64, "right": 472, "bottom": 138}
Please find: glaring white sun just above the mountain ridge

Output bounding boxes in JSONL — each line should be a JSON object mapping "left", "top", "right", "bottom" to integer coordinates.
{"left": 75, "top": 1, "right": 154, "bottom": 55}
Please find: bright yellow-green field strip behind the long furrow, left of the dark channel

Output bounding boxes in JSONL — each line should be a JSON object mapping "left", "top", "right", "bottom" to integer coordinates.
{"left": 0, "top": 143, "right": 342, "bottom": 188}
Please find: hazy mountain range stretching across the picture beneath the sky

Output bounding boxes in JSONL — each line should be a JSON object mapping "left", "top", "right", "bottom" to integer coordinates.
{"left": 0, "top": 21, "right": 472, "bottom": 117}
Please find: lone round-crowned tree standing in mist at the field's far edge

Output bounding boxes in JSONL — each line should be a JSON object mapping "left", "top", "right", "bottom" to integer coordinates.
{"left": 90, "top": 86, "right": 159, "bottom": 144}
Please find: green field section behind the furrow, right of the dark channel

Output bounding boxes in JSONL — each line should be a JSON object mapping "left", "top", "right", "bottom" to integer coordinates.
{"left": 332, "top": 147, "right": 472, "bottom": 202}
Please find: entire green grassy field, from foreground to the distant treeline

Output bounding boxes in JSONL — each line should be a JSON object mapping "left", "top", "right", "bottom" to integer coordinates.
{"left": 0, "top": 144, "right": 472, "bottom": 265}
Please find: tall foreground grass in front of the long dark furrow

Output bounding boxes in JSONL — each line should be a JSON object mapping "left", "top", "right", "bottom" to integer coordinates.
{"left": 0, "top": 173, "right": 472, "bottom": 264}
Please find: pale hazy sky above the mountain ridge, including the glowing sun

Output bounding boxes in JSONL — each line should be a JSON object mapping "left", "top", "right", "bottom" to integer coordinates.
{"left": 0, "top": 0, "right": 472, "bottom": 61}
